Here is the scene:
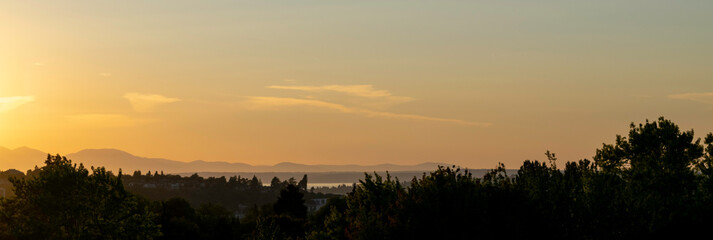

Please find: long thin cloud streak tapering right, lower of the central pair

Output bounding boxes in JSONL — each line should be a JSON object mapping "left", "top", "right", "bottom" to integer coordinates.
{"left": 246, "top": 97, "right": 492, "bottom": 127}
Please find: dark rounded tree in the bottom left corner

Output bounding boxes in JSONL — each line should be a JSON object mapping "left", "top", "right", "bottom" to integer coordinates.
{"left": 0, "top": 155, "right": 160, "bottom": 239}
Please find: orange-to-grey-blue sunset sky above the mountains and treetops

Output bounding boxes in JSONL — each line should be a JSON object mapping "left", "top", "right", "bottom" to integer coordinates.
{"left": 0, "top": 0, "right": 713, "bottom": 168}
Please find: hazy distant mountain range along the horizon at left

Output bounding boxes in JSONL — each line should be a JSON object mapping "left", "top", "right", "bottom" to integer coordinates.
{"left": 0, "top": 147, "right": 450, "bottom": 173}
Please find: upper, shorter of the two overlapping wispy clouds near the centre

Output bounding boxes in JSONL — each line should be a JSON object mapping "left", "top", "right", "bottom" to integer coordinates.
{"left": 267, "top": 85, "right": 415, "bottom": 107}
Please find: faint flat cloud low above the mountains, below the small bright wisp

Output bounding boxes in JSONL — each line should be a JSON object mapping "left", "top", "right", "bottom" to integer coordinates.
{"left": 66, "top": 114, "right": 155, "bottom": 128}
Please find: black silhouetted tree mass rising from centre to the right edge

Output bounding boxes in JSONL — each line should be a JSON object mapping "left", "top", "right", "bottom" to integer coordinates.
{"left": 309, "top": 118, "right": 713, "bottom": 239}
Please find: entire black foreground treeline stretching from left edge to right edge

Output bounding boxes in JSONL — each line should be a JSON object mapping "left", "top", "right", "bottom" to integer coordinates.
{"left": 0, "top": 118, "right": 713, "bottom": 239}
